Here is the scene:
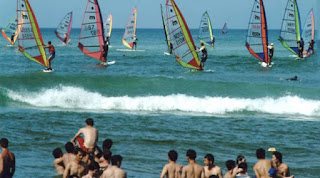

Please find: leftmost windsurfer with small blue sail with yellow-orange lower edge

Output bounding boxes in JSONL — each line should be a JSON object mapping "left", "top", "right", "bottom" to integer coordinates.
{"left": 1, "top": 15, "right": 20, "bottom": 45}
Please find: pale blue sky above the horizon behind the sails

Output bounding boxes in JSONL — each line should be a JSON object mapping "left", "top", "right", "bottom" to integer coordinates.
{"left": 0, "top": 0, "right": 320, "bottom": 29}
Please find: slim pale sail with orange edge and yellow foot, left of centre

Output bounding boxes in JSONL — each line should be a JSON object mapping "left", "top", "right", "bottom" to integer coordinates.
{"left": 122, "top": 8, "right": 137, "bottom": 49}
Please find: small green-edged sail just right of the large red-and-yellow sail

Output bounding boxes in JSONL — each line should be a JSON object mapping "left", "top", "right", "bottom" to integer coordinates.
{"left": 198, "top": 12, "right": 213, "bottom": 45}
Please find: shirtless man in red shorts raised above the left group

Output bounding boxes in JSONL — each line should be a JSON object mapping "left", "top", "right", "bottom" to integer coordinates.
{"left": 71, "top": 118, "right": 98, "bottom": 153}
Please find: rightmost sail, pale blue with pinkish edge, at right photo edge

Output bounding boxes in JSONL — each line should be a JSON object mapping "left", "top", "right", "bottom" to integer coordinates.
{"left": 302, "top": 9, "right": 315, "bottom": 49}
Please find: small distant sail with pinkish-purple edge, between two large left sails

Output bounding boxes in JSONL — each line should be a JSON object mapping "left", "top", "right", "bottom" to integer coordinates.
{"left": 55, "top": 12, "right": 72, "bottom": 43}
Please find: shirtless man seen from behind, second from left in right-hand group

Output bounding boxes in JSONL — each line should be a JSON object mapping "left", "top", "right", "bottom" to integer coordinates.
{"left": 181, "top": 149, "right": 204, "bottom": 178}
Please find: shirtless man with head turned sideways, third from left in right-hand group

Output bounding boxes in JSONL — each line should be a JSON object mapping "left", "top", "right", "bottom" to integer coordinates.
{"left": 203, "top": 154, "right": 222, "bottom": 178}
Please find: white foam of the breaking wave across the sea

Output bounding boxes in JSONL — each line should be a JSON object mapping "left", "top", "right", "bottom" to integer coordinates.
{"left": 8, "top": 86, "right": 320, "bottom": 116}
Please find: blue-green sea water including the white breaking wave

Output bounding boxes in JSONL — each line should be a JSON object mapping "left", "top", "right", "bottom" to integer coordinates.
{"left": 0, "top": 29, "right": 320, "bottom": 177}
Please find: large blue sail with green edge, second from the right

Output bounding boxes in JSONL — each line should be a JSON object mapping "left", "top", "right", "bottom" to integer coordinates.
{"left": 279, "top": 0, "right": 301, "bottom": 54}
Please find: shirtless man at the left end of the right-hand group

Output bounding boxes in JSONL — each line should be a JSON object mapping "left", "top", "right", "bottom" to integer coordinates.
{"left": 160, "top": 150, "right": 182, "bottom": 178}
